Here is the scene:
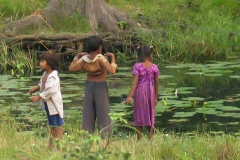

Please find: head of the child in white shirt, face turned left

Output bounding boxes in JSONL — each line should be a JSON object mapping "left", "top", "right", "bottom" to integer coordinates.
{"left": 40, "top": 52, "right": 60, "bottom": 71}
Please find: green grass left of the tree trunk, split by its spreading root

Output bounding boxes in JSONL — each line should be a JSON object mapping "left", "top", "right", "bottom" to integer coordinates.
{"left": 0, "top": 0, "right": 91, "bottom": 34}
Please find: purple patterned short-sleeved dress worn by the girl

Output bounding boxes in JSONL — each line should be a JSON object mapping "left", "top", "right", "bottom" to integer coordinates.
{"left": 133, "top": 63, "right": 160, "bottom": 128}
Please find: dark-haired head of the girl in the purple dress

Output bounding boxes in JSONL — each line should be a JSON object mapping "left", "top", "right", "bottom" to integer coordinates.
{"left": 137, "top": 45, "right": 153, "bottom": 62}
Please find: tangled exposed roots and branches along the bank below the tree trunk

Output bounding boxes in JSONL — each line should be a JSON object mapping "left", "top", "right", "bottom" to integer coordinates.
{"left": 0, "top": 32, "right": 137, "bottom": 54}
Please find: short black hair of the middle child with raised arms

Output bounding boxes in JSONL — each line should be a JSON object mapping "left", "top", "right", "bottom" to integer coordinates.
{"left": 87, "top": 36, "right": 103, "bottom": 52}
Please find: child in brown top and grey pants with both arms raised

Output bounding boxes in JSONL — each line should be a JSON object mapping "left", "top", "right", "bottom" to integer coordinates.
{"left": 69, "top": 36, "right": 117, "bottom": 136}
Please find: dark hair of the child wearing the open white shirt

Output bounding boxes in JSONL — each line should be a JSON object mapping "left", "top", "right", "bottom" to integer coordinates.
{"left": 41, "top": 52, "right": 60, "bottom": 70}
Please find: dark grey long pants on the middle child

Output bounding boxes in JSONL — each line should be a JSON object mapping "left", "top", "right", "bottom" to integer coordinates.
{"left": 82, "top": 81, "right": 112, "bottom": 137}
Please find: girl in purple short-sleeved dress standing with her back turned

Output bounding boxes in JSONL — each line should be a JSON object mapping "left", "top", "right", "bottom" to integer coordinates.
{"left": 125, "top": 46, "right": 159, "bottom": 140}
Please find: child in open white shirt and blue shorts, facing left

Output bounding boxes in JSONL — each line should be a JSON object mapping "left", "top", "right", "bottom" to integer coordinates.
{"left": 29, "top": 52, "right": 64, "bottom": 149}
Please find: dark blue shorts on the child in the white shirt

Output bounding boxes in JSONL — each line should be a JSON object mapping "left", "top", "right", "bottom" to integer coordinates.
{"left": 44, "top": 102, "right": 64, "bottom": 127}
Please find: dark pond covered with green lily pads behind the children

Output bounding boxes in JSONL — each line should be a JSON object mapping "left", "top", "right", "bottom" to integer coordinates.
{"left": 0, "top": 60, "right": 240, "bottom": 134}
